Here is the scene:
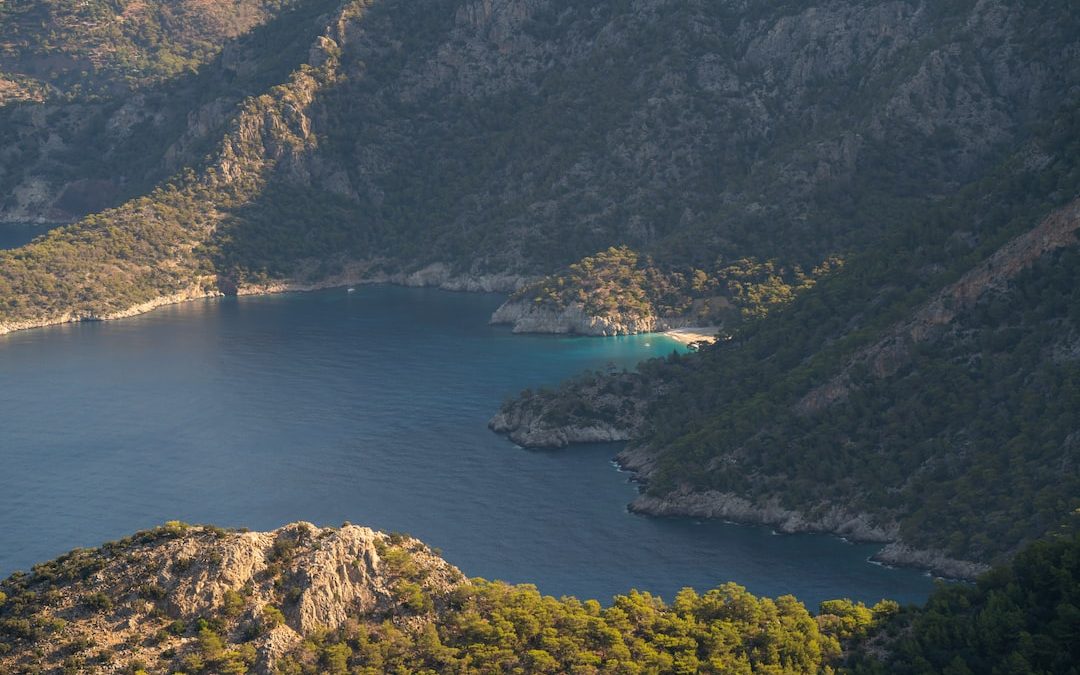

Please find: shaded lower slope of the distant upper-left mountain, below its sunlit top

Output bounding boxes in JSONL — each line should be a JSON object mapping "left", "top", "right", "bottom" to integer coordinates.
{"left": 0, "top": 0, "right": 339, "bottom": 222}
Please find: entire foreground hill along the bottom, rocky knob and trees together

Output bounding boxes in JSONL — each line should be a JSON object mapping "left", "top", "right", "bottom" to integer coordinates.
{"left": 8, "top": 522, "right": 1080, "bottom": 675}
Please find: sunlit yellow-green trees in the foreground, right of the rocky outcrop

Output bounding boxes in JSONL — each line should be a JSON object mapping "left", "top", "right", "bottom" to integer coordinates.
{"left": 276, "top": 579, "right": 876, "bottom": 675}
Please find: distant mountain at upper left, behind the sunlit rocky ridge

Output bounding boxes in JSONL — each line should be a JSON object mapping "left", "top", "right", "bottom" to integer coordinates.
{"left": 0, "top": 0, "right": 337, "bottom": 222}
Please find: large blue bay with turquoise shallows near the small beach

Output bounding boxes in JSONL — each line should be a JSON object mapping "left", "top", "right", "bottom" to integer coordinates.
{"left": 0, "top": 286, "right": 931, "bottom": 607}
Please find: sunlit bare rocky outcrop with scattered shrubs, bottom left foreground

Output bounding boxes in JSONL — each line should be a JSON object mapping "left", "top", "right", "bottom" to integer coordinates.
{"left": 0, "top": 523, "right": 464, "bottom": 673}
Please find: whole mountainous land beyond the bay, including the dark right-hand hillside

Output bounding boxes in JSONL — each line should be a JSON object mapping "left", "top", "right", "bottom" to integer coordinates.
{"left": 0, "top": 0, "right": 1080, "bottom": 613}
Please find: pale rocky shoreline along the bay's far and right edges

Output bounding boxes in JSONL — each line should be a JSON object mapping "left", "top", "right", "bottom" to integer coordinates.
{"left": 0, "top": 258, "right": 989, "bottom": 579}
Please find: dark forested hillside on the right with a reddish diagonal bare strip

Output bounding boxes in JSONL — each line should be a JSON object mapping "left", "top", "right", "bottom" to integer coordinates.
{"left": 494, "top": 99, "right": 1080, "bottom": 576}
